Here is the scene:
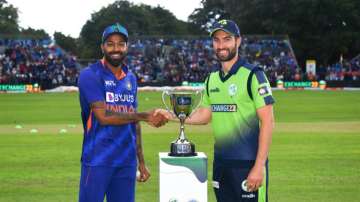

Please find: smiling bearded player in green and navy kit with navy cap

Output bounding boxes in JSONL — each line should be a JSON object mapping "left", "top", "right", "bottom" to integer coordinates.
{"left": 161, "top": 20, "right": 274, "bottom": 202}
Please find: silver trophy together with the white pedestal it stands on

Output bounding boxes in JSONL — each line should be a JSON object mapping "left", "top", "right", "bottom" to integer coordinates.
{"left": 159, "top": 91, "right": 207, "bottom": 202}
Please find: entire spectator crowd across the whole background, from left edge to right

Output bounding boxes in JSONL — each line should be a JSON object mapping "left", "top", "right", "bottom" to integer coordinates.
{"left": 0, "top": 36, "right": 360, "bottom": 89}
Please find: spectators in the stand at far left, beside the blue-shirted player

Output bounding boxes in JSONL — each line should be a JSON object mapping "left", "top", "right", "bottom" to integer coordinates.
{"left": 0, "top": 39, "right": 80, "bottom": 89}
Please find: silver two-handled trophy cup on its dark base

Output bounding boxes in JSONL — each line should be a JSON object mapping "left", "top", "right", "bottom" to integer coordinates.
{"left": 162, "top": 91, "right": 202, "bottom": 156}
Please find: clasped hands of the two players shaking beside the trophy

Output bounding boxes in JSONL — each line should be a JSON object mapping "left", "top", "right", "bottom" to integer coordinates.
{"left": 146, "top": 109, "right": 176, "bottom": 128}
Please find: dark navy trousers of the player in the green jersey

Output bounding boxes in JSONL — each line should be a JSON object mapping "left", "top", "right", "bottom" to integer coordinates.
{"left": 213, "top": 161, "right": 269, "bottom": 202}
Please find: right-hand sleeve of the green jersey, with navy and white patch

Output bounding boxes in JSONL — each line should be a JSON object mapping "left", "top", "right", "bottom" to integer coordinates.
{"left": 251, "top": 71, "right": 275, "bottom": 109}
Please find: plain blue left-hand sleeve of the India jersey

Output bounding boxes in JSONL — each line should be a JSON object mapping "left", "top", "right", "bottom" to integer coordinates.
{"left": 78, "top": 69, "right": 105, "bottom": 104}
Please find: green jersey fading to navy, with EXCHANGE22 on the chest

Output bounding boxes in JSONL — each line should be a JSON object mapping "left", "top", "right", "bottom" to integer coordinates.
{"left": 201, "top": 60, "right": 274, "bottom": 160}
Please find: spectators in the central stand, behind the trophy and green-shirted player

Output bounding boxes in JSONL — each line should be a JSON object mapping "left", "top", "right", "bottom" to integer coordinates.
{"left": 128, "top": 36, "right": 299, "bottom": 82}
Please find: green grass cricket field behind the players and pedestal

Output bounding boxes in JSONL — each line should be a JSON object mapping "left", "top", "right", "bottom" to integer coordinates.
{"left": 0, "top": 91, "right": 360, "bottom": 202}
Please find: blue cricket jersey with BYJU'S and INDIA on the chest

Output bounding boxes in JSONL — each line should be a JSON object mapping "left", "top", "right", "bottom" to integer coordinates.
{"left": 78, "top": 61, "right": 137, "bottom": 167}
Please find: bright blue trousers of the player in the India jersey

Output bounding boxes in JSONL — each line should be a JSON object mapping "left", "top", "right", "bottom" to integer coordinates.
{"left": 79, "top": 165, "right": 136, "bottom": 202}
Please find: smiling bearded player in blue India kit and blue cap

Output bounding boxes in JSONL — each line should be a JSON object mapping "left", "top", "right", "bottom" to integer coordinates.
{"left": 78, "top": 24, "right": 167, "bottom": 202}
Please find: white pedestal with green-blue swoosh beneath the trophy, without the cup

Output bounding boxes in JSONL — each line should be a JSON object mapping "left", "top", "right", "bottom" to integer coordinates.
{"left": 159, "top": 152, "right": 208, "bottom": 202}
